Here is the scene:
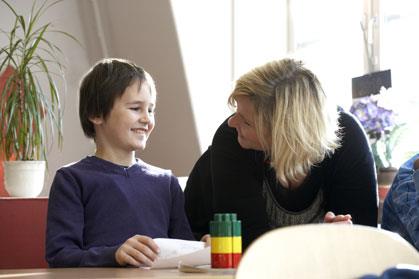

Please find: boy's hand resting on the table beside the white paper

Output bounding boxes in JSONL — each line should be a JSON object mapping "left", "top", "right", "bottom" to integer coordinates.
{"left": 115, "top": 235, "right": 160, "bottom": 267}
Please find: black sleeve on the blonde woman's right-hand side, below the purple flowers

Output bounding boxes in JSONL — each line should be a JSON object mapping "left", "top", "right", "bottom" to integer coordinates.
{"left": 325, "top": 112, "right": 378, "bottom": 227}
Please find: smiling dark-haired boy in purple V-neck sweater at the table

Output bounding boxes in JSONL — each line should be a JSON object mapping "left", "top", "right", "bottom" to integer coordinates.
{"left": 46, "top": 59, "right": 193, "bottom": 267}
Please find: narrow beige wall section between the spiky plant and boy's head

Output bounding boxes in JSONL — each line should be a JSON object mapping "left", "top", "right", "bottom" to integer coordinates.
{"left": 44, "top": 1, "right": 98, "bottom": 195}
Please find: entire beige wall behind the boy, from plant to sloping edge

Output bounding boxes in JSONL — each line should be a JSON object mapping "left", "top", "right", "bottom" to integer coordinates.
{"left": 0, "top": 0, "right": 208, "bottom": 195}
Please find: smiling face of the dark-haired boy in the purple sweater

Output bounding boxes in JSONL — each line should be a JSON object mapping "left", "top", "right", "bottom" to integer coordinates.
{"left": 92, "top": 81, "right": 156, "bottom": 154}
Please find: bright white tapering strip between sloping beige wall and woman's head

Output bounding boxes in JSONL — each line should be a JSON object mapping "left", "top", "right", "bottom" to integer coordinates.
{"left": 171, "top": 0, "right": 233, "bottom": 151}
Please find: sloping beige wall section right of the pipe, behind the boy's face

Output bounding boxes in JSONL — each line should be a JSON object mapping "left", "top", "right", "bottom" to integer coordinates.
{"left": 81, "top": 0, "right": 205, "bottom": 176}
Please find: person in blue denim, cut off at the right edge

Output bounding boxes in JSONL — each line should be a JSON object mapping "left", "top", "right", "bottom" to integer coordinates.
{"left": 381, "top": 154, "right": 419, "bottom": 250}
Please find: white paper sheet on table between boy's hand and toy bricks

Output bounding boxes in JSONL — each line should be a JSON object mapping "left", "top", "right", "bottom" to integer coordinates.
{"left": 151, "top": 238, "right": 211, "bottom": 268}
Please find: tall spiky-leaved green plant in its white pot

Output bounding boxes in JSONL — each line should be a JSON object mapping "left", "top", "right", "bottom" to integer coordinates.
{"left": 0, "top": 0, "right": 77, "bottom": 197}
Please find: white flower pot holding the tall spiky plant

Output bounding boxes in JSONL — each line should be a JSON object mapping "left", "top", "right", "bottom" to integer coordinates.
{"left": 3, "top": 161, "right": 45, "bottom": 198}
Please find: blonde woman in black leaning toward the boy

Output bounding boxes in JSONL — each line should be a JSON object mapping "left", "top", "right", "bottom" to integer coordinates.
{"left": 185, "top": 59, "right": 377, "bottom": 248}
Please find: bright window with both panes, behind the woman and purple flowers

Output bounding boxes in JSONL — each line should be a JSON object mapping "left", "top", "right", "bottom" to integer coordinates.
{"left": 288, "top": 0, "right": 419, "bottom": 167}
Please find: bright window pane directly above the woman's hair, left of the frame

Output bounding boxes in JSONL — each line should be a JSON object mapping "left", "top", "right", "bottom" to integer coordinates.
{"left": 288, "top": 0, "right": 364, "bottom": 111}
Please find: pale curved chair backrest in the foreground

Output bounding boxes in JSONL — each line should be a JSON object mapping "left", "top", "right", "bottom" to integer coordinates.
{"left": 236, "top": 224, "right": 419, "bottom": 279}
